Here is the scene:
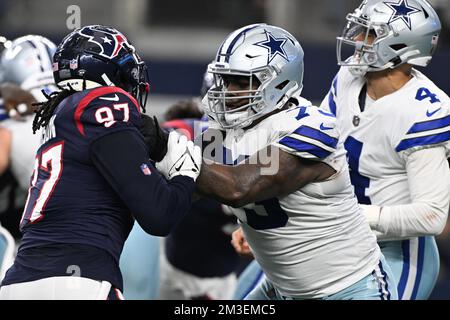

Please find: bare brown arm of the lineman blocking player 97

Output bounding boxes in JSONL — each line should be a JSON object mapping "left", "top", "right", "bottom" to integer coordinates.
{"left": 197, "top": 146, "right": 335, "bottom": 207}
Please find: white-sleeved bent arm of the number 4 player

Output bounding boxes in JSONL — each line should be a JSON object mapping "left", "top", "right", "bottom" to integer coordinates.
{"left": 363, "top": 147, "right": 450, "bottom": 239}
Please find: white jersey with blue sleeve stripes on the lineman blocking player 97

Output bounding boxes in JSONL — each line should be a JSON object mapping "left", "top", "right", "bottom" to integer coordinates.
{"left": 210, "top": 99, "right": 380, "bottom": 299}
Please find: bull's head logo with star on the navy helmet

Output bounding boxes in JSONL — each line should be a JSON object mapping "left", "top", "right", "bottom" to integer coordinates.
{"left": 79, "top": 27, "right": 131, "bottom": 59}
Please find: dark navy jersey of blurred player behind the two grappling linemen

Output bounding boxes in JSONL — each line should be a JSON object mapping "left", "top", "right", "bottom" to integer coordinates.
{"left": 162, "top": 119, "right": 240, "bottom": 278}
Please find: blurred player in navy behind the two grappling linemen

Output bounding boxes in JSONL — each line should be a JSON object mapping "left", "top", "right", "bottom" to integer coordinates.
{"left": 159, "top": 96, "right": 242, "bottom": 300}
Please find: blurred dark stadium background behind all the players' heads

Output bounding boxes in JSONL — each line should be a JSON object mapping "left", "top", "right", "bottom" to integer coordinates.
{"left": 0, "top": 0, "right": 450, "bottom": 299}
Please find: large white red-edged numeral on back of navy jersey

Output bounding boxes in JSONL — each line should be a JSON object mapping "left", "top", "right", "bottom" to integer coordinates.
{"left": 20, "top": 142, "right": 64, "bottom": 227}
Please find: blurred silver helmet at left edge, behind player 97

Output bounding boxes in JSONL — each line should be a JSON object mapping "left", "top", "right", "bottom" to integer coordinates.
{"left": 0, "top": 35, "right": 56, "bottom": 100}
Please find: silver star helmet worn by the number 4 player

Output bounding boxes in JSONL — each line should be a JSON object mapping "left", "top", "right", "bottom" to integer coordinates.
{"left": 337, "top": 0, "right": 441, "bottom": 76}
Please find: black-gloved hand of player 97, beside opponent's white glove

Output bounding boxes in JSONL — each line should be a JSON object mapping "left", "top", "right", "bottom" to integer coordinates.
{"left": 140, "top": 114, "right": 169, "bottom": 162}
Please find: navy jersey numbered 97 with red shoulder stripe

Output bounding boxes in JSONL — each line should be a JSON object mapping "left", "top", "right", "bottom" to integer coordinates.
{"left": 3, "top": 87, "right": 141, "bottom": 288}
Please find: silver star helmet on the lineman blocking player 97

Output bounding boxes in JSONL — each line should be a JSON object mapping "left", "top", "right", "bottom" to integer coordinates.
{"left": 202, "top": 24, "right": 303, "bottom": 129}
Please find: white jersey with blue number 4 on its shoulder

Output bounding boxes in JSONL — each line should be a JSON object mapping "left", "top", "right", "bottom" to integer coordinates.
{"left": 321, "top": 68, "right": 450, "bottom": 240}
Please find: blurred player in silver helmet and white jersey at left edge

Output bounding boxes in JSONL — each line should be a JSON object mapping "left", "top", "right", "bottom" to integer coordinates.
{"left": 0, "top": 35, "right": 56, "bottom": 190}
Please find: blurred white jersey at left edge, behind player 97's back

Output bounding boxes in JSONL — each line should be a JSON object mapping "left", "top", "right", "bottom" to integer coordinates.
{"left": 0, "top": 115, "right": 41, "bottom": 190}
